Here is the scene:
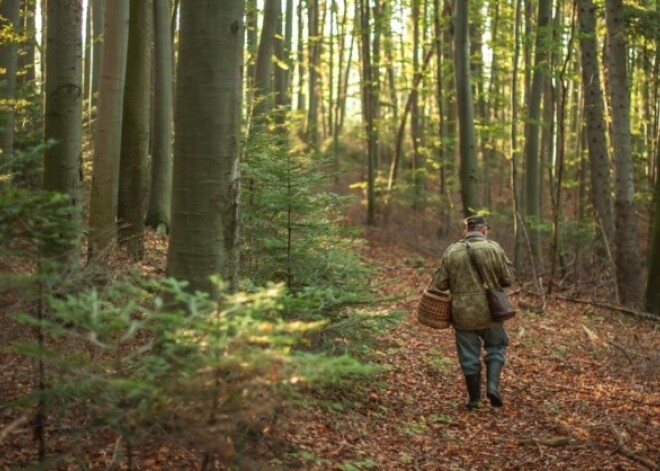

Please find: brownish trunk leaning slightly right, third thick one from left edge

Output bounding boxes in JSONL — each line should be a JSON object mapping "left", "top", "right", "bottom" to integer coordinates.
{"left": 89, "top": 0, "right": 130, "bottom": 258}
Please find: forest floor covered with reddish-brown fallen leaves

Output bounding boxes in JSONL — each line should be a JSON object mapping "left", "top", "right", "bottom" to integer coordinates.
{"left": 0, "top": 218, "right": 660, "bottom": 471}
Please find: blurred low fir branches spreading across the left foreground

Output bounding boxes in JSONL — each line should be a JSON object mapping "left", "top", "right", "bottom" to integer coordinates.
{"left": 13, "top": 275, "right": 372, "bottom": 458}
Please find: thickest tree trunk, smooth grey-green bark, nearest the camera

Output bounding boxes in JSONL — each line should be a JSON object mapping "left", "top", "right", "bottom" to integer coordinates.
{"left": 167, "top": 0, "right": 245, "bottom": 297}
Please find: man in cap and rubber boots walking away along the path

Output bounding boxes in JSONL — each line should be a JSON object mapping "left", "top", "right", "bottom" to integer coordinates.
{"left": 434, "top": 216, "right": 514, "bottom": 410}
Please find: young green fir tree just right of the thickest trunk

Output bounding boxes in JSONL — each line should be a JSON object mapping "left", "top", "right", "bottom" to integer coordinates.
{"left": 241, "top": 121, "right": 400, "bottom": 354}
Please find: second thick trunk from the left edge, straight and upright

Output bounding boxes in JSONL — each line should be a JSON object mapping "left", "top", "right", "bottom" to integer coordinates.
{"left": 43, "top": 0, "right": 83, "bottom": 267}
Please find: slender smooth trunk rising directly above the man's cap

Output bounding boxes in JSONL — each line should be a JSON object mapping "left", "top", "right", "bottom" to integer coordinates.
{"left": 454, "top": 2, "right": 481, "bottom": 216}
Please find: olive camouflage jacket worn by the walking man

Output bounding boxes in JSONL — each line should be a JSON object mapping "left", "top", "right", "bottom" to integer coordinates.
{"left": 433, "top": 232, "right": 514, "bottom": 330}
